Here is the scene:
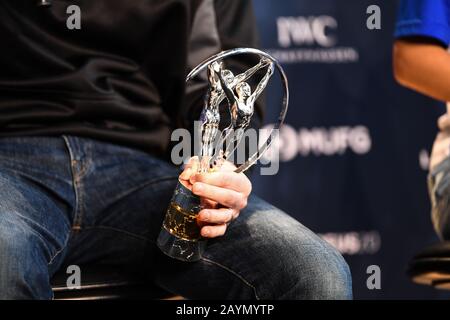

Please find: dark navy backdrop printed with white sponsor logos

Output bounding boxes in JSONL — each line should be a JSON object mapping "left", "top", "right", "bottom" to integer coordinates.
{"left": 253, "top": 0, "right": 448, "bottom": 299}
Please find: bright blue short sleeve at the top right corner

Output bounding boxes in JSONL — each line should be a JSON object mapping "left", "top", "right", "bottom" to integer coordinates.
{"left": 395, "top": 0, "right": 450, "bottom": 46}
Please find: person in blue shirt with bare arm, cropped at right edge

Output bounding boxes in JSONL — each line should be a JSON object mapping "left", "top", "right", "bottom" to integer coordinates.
{"left": 393, "top": 0, "right": 450, "bottom": 240}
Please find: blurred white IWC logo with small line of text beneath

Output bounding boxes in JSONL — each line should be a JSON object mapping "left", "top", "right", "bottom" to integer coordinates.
{"left": 266, "top": 15, "right": 359, "bottom": 64}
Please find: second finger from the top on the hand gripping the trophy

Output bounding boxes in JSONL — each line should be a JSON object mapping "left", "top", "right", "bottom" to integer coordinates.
{"left": 192, "top": 182, "right": 247, "bottom": 210}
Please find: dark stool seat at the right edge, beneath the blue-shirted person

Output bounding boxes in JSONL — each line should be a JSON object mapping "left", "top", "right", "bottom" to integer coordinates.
{"left": 407, "top": 241, "right": 450, "bottom": 290}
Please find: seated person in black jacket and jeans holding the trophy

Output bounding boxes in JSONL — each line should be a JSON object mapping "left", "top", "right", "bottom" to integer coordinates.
{"left": 0, "top": 0, "right": 352, "bottom": 299}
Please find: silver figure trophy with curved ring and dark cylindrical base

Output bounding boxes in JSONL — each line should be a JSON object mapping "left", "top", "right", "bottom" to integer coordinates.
{"left": 157, "top": 48, "right": 289, "bottom": 261}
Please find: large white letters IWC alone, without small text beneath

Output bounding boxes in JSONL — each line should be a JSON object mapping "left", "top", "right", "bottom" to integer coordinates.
{"left": 277, "top": 16, "right": 338, "bottom": 48}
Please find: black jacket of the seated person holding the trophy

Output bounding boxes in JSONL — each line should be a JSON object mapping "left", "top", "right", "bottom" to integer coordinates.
{"left": 0, "top": 0, "right": 261, "bottom": 155}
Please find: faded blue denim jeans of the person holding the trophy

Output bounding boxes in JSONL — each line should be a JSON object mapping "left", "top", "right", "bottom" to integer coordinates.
{"left": 0, "top": 136, "right": 352, "bottom": 299}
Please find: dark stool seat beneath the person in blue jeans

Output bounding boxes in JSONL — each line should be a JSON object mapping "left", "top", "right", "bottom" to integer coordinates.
{"left": 51, "top": 266, "right": 174, "bottom": 300}
